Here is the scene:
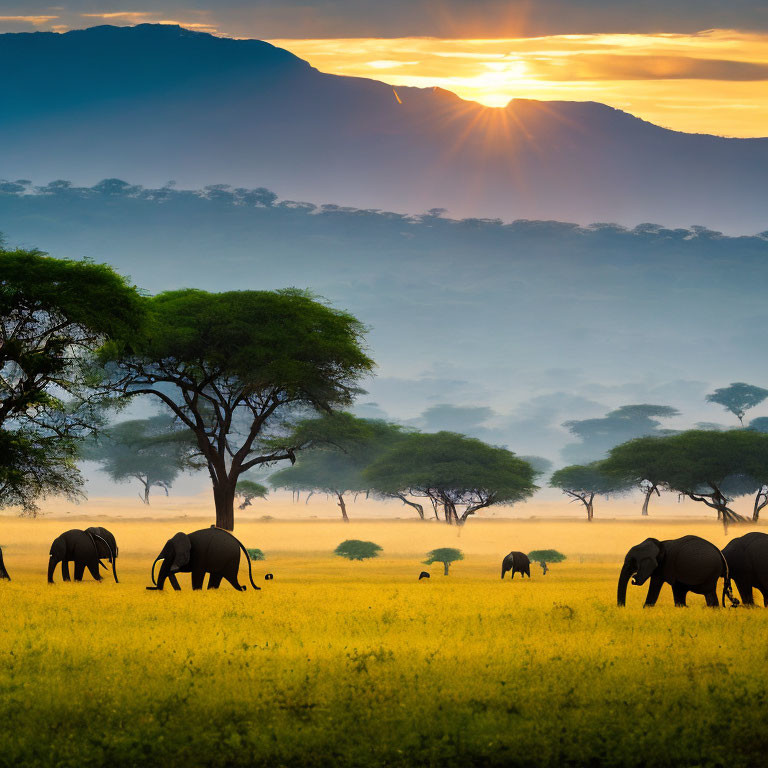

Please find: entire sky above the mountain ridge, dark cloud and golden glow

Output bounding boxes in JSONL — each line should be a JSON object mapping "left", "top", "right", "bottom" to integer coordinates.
{"left": 0, "top": 0, "right": 768, "bottom": 136}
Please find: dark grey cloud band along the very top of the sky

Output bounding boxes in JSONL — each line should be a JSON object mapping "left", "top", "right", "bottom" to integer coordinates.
{"left": 0, "top": 0, "right": 768, "bottom": 39}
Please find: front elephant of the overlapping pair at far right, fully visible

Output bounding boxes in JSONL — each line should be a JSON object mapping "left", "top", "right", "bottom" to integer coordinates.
{"left": 616, "top": 536, "right": 738, "bottom": 608}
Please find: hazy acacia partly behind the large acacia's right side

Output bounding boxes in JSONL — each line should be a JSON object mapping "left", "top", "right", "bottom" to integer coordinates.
{"left": 269, "top": 413, "right": 416, "bottom": 522}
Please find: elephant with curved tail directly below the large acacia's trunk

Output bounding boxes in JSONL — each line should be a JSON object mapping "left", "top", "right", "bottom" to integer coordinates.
{"left": 147, "top": 525, "right": 261, "bottom": 592}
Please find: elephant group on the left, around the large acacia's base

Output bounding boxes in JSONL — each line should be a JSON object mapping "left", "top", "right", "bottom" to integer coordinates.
{"left": 0, "top": 526, "right": 260, "bottom": 591}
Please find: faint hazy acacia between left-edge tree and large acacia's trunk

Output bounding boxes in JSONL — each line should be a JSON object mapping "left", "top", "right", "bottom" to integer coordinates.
{"left": 82, "top": 414, "right": 202, "bottom": 504}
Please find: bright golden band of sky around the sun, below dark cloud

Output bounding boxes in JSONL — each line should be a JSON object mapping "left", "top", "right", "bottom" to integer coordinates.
{"left": 269, "top": 30, "right": 768, "bottom": 136}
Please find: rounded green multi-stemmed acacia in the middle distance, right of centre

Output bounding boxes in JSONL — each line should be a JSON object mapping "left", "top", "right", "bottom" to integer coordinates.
{"left": 363, "top": 432, "right": 537, "bottom": 525}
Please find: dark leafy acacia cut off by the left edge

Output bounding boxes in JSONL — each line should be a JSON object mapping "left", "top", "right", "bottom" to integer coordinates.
{"left": 0, "top": 244, "right": 143, "bottom": 515}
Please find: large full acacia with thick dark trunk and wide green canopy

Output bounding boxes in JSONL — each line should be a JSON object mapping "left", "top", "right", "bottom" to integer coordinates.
{"left": 104, "top": 289, "right": 373, "bottom": 530}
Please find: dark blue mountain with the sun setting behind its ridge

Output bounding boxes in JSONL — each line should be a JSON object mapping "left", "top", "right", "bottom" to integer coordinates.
{"left": 0, "top": 25, "right": 768, "bottom": 233}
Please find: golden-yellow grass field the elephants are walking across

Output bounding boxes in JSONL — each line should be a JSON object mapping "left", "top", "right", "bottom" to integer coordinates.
{"left": 0, "top": 517, "right": 768, "bottom": 768}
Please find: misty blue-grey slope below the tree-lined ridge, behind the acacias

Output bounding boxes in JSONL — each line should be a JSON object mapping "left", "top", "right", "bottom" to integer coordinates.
{"left": 0, "top": 185, "right": 768, "bottom": 458}
